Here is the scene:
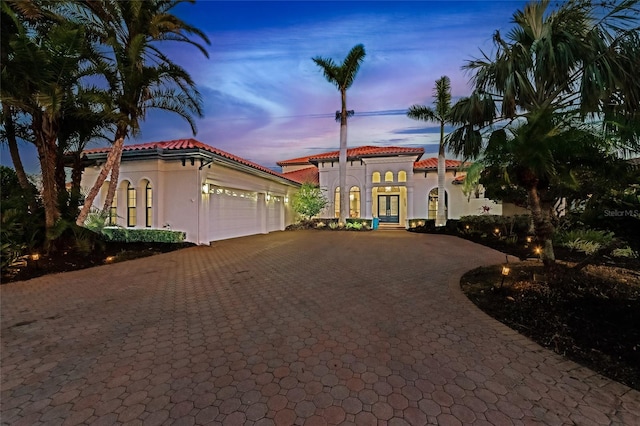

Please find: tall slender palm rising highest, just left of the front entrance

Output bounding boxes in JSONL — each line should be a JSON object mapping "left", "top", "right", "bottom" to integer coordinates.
{"left": 312, "top": 44, "right": 366, "bottom": 223}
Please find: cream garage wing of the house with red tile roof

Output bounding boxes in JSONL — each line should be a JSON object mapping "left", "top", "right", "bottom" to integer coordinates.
{"left": 81, "top": 139, "right": 300, "bottom": 244}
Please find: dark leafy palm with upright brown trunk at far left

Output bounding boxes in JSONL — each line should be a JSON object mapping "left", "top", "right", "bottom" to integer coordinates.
{"left": 2, "top": 2, "right": 91, "bottom": 241}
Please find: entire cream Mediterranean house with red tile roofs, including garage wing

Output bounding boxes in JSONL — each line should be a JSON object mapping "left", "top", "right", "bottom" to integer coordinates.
{"left": 81, "top": 139, "right": 510, "bottom": 244}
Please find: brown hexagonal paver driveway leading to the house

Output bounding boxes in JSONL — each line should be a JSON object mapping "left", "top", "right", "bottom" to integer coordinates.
{"left": 1, "top": 231, "right": 640, "bottom": 425}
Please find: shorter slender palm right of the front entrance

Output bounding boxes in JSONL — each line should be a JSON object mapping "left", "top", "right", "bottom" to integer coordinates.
{"left": 407, "top": 75, "right": 452, "bottom": 226}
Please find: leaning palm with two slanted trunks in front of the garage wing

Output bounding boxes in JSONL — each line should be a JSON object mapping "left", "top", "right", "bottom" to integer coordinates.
{"left": 76, "top": 0, "right": 209, "bottom": 225}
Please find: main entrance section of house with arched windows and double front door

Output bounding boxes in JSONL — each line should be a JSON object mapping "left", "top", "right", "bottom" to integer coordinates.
{"left": 278, "top": 146, "right": 503, "bottom": 227}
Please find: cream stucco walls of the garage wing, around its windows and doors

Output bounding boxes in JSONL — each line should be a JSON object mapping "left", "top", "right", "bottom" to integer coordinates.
{"left": 81, "top": 159, "right": 297, "bottom": 244}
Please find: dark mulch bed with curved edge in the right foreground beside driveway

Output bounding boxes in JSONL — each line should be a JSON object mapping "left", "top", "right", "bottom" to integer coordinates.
{"left": 461, "top": 261, "right": 640, "bottom": 390}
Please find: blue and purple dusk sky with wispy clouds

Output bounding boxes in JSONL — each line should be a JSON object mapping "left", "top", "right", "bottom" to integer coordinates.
{"left": 0, "top": 1, "right": 525, "bottom": 173}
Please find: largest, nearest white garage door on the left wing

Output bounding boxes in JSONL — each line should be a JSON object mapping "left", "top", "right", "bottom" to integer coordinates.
{"left": 209, "top": 188, "right": 261, "bottom": 241}
